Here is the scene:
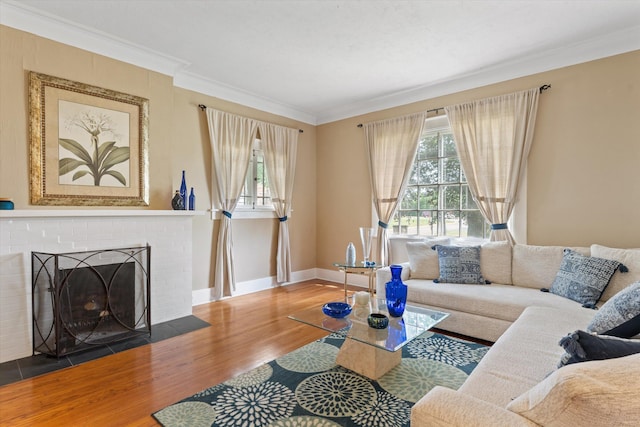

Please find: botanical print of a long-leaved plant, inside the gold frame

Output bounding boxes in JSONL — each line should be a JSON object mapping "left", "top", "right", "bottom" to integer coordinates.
{"left": 58, "top": 100, "right": 130, "bottom": 187}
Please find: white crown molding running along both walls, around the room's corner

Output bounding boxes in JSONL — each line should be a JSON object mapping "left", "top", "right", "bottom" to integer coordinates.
{"left": 0, "top": 0, "right": 640, "bottom": 125}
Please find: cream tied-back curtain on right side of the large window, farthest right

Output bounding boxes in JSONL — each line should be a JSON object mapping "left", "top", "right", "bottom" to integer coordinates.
{"left": 445, "top": 88, "right": 540, "bottom": 244}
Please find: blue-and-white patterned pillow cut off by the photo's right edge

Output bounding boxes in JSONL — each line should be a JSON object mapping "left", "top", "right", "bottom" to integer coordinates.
{"left": 587, "top": 282, "right": 640, "bottom": 338}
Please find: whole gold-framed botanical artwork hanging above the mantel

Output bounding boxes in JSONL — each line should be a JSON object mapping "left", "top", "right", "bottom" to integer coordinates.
{"left": 29, "top": 71, "right": 149, "bottom": 206}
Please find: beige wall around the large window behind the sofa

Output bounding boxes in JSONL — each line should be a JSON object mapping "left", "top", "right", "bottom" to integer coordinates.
{"left": 317, "top": 51, "right": 640, "bottom": 268}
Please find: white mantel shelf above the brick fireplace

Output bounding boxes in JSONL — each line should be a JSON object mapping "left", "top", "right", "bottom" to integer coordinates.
{"left": 0, "top": 209, "right": 206, "bottom": 219}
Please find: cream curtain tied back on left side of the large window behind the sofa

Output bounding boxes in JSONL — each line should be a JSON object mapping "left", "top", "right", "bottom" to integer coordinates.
{"left": 364, "top": 112, "right": 427, "bottom": 265}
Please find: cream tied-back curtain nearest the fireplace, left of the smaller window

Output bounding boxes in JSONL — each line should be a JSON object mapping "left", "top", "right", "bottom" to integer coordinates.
{"left": 206, "top": 108, "right": 258, "bottom": 300}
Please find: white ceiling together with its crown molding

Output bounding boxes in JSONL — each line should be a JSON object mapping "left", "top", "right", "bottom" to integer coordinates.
{"left": 0, "top": 0, "right": 640, "bottom": 124}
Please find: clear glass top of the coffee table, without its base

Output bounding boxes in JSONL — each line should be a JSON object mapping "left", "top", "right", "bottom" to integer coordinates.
{"left": 289, "top": 299, "right": 449, "bottom": 351}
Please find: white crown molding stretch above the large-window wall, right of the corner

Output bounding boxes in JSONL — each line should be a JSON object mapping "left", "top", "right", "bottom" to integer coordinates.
{"left": 317, "top": 26, "right": 640, "bottom": 124}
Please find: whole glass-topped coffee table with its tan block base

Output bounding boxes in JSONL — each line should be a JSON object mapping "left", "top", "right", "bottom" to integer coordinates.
{"left": 289, "top": 299, "right": 449, "bottom": 380}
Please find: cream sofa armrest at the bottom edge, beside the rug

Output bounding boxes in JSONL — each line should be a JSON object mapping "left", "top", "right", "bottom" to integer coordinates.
{"left": 411, "top": 386, "right": 538, "bottom": 427}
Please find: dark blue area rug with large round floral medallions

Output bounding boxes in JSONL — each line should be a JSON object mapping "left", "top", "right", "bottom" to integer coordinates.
{"left": 153, "top": 332, "right": 489, "bottom": 427}
